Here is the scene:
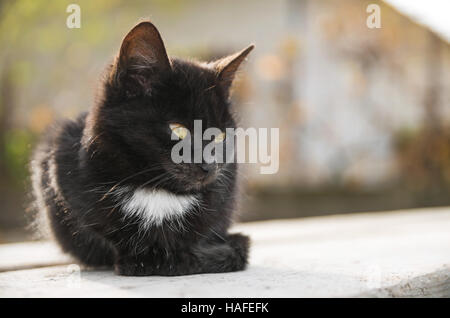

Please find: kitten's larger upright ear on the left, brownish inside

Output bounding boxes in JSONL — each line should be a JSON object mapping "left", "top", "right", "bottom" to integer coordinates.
{"left": 110, "top": 21, "right": 172, "bottom": 90}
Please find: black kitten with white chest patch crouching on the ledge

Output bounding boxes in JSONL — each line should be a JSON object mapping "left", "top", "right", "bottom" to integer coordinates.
{"left": 31, "top": 22, "right": 253, "bottom": 275}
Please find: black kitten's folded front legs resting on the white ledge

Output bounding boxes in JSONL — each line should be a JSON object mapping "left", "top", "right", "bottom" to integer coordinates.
{"left": 115, "top": 234, "right": 250, "bottom": 276}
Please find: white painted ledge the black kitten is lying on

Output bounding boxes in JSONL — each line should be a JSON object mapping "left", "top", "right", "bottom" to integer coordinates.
{"left": 0, "top": 208, "right": 450, "bottom": 297}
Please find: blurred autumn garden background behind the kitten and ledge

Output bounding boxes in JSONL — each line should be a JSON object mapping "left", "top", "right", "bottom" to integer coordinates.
{"left": 0, "top": 0, "right": 450, "bottom": 243}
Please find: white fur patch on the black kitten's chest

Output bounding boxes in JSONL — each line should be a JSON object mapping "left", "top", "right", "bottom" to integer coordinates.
{"left": 122, "top": 189, "right": 199, "bottom": 226}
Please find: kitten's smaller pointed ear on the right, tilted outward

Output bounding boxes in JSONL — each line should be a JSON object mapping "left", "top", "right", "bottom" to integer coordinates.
{"left": 212, "top": 44, "right": 255, "bottom": 92}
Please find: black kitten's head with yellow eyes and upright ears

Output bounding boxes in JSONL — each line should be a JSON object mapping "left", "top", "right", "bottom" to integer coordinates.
{"left": 84, "top": 22, "right": 253, "bottom": 191}
